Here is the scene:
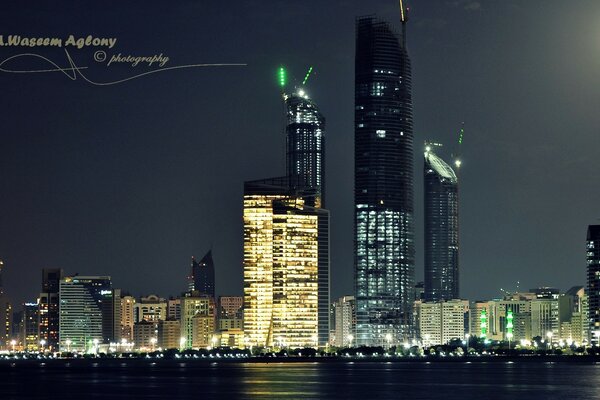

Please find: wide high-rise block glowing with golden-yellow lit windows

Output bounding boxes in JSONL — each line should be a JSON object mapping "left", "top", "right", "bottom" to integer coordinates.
{"left": 244, "top": 178, "right": 329, "bottom": 347}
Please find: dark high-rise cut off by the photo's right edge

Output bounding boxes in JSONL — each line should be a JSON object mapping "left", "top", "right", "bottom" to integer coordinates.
{"left": 587, "top": 225, "right": 600, "bottom": 345}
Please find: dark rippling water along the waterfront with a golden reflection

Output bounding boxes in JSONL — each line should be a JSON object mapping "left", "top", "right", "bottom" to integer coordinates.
{"left": 0, "top": 360, "right": 600, "bottom": 400}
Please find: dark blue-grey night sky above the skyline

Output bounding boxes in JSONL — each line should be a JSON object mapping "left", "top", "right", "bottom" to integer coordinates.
{"left": 0, "top": 0, "right": 600, "bottom": 302}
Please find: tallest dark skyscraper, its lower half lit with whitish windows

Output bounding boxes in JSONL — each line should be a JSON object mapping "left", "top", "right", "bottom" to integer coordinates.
{"left": 354, "top": 4, "right": 414, "bottom": 345}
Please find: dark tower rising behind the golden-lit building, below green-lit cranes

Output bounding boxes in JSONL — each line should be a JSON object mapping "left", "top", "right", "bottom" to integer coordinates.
{"left": 284, "top": 89, "right": 325, "bottom": 204}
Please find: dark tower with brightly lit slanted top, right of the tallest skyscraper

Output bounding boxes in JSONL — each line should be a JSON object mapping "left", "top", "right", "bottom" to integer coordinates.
{"left": 423, "top": 145, "right": 459, "bottom": 301}
